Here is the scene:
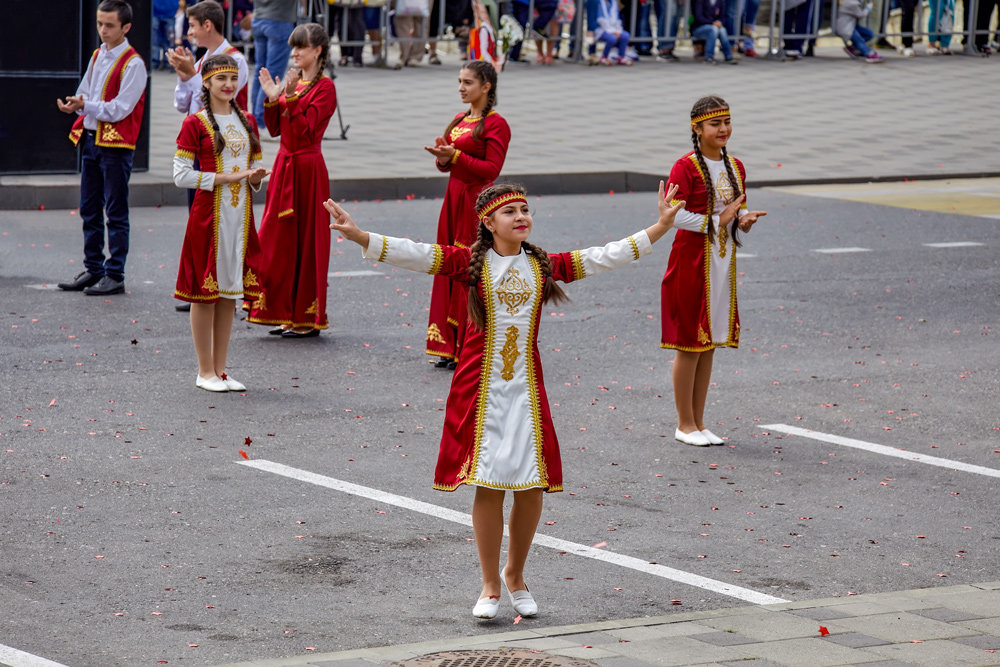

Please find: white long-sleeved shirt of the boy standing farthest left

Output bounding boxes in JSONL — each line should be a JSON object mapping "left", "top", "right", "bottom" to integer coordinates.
{"left": 76, "top": 39, "right": 146, "bottom": 130}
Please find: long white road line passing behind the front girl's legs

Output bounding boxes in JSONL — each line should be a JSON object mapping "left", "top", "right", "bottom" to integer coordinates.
{"left": 237, "top": 459, "right": 788, "bottom": 604}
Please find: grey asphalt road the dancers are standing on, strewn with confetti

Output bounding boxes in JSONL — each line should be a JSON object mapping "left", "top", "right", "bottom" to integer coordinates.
{"left": 0, "top": 184, "right": 1000, "bottom": 667}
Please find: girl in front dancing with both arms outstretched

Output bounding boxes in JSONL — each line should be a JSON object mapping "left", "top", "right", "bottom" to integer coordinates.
{"left": 324, "top": 181, "right": 684, "bottom": 618}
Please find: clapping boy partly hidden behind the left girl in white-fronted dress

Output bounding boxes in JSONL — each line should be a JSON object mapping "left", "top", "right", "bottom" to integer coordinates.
{"left": 167, "top": 0, "right": 250, "bottom": 114}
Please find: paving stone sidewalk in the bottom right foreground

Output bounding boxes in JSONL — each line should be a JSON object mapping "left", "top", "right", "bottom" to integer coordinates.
{"left": 213, "top": 581, "right": 1000, "bottom": 667}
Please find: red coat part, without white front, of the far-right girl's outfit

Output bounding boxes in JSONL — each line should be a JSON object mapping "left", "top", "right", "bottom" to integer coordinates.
{"left": 660, "top": 151, "right": 746, "bottom": 352}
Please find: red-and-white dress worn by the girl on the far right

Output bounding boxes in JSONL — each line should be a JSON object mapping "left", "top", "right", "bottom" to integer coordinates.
{"left": 660, "top": 151, "right": 746, "bottom": 352}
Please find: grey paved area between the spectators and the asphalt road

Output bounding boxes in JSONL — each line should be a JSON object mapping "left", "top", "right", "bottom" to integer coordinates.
{"left": 0, "top": 46, "right": 1000, "bottom": 209}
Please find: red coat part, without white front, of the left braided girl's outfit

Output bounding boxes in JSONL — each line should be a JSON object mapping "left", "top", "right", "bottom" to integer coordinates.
{"left": 174, "top": 113, "right": 261, "bottom": 303}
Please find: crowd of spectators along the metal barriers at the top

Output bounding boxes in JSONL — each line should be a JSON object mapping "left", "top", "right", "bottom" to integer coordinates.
{"left": 152, "top": 0, "right": 1000, "bottom": 69}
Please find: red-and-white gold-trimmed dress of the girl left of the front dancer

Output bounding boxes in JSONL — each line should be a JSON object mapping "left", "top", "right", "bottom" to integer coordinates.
{"left": 174, "top": 110, "right": 261, "bottom": 303}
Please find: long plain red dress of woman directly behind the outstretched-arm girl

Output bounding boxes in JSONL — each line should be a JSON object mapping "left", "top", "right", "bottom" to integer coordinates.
{"left": 426, "top": 111, "right": 510, "bottom": 359}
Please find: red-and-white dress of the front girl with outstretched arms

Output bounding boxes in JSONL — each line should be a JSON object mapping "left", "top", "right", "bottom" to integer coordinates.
{"left": 365, "top": 232, "right": 652, "bottom": 492}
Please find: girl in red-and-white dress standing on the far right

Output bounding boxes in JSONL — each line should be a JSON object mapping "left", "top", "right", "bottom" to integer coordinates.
{"left": 660, "top": 96, "right": 767, "bottom": 446}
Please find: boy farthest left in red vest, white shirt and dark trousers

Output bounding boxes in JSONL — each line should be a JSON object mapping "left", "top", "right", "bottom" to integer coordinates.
{"left": 56, "top": 0, "right": 146, "bottom": 296}
